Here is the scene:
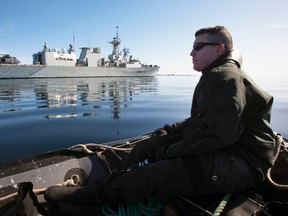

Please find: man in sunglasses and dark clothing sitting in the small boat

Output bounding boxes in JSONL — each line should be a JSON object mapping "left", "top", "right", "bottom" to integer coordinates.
{"left": 45, "top": 26, "right": 274, "bottom": 204}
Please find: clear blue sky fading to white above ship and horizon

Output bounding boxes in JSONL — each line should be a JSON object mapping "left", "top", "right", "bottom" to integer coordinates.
{"left": 0, "top": 0, "right": 288, "bottom": 77}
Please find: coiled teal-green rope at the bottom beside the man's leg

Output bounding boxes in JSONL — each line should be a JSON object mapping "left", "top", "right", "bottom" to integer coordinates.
{"left": 102, "top": 198, "right": 164, "bottom": 216}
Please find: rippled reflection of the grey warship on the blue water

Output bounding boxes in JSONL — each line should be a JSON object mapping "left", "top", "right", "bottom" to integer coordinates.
{"left": 0, "top": 77, "right": 157, "bottom": 119}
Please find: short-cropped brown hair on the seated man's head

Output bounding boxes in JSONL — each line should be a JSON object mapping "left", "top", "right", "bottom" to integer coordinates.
{"left": 195, "top": 26, "right": 233, "bottom": 49}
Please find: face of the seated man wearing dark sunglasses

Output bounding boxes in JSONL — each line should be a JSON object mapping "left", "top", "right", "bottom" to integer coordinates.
{"left": 190, "top": 34, "right": 220, "bottom": 71}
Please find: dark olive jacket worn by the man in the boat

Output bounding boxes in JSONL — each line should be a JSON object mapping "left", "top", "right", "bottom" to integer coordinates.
{"left": 167, "top": 50, "right": 274, "bottom": 172}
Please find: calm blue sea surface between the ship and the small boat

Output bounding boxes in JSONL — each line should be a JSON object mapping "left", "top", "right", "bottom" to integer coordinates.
{"left": 0, "top": 76, "right": 288, "bottom": 163}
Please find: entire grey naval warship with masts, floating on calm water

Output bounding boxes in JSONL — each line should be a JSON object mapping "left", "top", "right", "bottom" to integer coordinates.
{"left": 0, "top": 28, "right": 160, "bottom": 78}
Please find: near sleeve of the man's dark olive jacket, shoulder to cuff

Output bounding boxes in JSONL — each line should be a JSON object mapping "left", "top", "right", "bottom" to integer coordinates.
{"left": 167, "top": 66, "right": 246, "bottom": 157}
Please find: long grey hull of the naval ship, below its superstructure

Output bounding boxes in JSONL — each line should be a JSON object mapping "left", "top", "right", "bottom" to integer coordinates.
{"left": 0, "top": 65, "right": 159, "bottom": 79}
